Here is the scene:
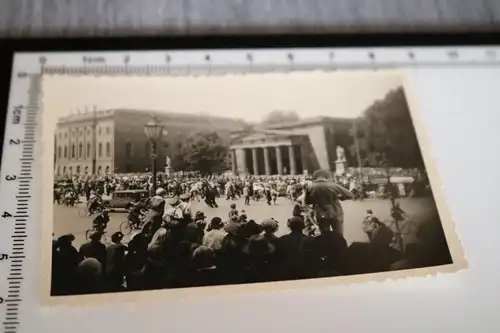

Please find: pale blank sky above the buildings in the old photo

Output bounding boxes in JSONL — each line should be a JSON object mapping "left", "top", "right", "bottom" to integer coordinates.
{"left": 43, "top": 71, "right": 401, "bottom": 122}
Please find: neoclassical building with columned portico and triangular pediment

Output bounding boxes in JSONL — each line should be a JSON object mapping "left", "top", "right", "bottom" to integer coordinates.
{"left": 230, "top": 117, "right": 354, "bottom": 175}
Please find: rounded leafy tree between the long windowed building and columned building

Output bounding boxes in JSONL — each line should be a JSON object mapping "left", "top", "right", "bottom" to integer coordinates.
{"left": 172, "top": 132, "right": 228, "bottom": 175}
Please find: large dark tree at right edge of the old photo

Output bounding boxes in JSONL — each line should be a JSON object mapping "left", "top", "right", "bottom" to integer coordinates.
{"left": 364, "top": 88, "right": 423, "bottom": 168}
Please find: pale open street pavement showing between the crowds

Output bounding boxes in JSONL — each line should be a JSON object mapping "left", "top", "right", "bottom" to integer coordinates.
{"left": 54, "top": 197, "right": 433, "bottom": 248}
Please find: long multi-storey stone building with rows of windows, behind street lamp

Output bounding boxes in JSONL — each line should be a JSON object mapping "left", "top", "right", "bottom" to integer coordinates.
{"left": 55, "top": 109, "right": 245, "bottom": 175}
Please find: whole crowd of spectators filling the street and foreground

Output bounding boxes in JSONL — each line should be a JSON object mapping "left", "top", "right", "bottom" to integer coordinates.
{"left": 51, "top": 170, "right": 448, "bottom": 295}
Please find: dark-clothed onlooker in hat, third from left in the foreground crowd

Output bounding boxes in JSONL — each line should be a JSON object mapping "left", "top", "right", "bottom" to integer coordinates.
{"left": 105, "top": 231, "right": 127, "bottom": 291}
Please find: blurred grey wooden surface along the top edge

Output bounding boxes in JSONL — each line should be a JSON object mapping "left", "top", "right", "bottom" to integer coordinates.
{"left": 0, "top": 0, "right": 500, "bottom": 36}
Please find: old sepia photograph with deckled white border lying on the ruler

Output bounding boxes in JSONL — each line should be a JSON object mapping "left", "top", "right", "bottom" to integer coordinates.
{"left": 43, "top": 71, "right": 464, "bottom": 296}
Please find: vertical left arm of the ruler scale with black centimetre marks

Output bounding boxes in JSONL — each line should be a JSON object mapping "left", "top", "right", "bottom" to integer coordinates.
{"left": 0, "top": 53, "right": 40, "bottom": 333}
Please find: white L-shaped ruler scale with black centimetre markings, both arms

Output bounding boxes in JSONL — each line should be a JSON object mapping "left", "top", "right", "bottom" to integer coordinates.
{"left": 0, "top": 46, "right": 500, "bottom": 333}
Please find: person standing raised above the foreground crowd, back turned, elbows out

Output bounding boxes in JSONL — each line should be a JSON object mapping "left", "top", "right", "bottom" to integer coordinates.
{"left": 304, "top": 170, "right": 354, "bottom": 235}
